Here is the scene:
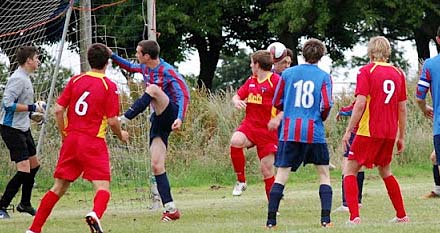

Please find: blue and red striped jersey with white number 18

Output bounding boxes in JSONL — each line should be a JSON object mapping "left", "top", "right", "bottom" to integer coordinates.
{"left": 273, "top": 64, "right": 333, "bottom": 143}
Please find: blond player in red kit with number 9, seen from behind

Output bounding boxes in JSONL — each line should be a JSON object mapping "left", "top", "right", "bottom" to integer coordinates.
{"left": 342, "top": 36, "right": 409, "bottom": 224}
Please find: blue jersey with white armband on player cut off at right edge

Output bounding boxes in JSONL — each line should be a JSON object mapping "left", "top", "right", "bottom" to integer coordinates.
{"left": 416, "top": 54, "right": 440, "bottom": 135}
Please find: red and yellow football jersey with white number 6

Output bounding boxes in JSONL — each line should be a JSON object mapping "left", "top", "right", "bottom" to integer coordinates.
{"left": 57, "top": 72, "right": 119, "bottom": 138}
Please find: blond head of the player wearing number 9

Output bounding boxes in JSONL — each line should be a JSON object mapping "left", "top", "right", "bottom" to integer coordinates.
{"left": 367, "top": 36, "right": 391, "bottom": 62}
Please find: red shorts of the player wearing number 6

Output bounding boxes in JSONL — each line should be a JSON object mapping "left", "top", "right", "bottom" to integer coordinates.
{"left": 54, "top": 133, "right": 110, "bottom": 181}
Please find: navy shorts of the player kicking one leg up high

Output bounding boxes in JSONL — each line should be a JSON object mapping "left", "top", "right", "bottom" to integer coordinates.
{"left": 150, "top": 102, "right": 179, "bottom": 147}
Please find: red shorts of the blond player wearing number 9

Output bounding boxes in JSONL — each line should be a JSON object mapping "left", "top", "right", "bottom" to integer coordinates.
{"left": 348, "top": 135, "right": 395, "bottom": 168}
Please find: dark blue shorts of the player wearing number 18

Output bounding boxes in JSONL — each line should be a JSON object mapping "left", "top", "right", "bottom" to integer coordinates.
{"left": 275, "top": 141, "right": 330, "bottom": 171}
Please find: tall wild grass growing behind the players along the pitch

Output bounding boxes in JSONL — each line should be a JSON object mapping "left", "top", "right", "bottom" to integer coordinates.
{"left": 0, "top": 78, "right": 433, "bottom": 190}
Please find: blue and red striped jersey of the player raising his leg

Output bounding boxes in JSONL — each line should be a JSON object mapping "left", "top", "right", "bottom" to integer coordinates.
{"left": 111, "top": 53, "right": 189, "bottom": 121}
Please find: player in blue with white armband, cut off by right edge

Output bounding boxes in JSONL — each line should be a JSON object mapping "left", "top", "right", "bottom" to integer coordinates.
{"left": 416, "top": 26, "right": 440, "bottom": 200}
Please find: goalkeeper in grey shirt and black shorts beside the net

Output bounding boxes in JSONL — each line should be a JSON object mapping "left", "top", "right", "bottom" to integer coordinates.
{"left": 0, "top": 46, "right": 44, "bottom": 219}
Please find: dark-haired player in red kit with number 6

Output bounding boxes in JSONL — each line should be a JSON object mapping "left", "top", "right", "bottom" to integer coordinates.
{"left": 27, "top": 43, "right": 128, "bottom": 233}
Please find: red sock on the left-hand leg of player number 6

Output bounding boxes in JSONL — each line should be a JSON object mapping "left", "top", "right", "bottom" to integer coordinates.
{"left": 29, "top": 191, "right": 60, "bottom": 232}
